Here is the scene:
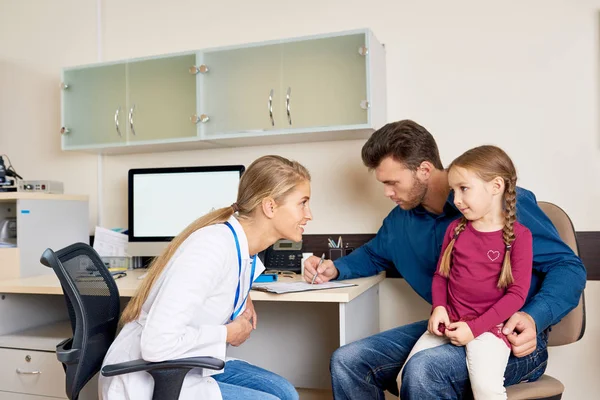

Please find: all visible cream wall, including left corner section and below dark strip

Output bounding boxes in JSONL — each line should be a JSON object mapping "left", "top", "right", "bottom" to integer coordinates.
{"left": 0, "top": 0, "right": 600, "bottom": 399}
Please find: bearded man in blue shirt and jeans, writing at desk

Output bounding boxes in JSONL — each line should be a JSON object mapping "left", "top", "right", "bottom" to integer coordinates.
{"left": 305, "top": 120, "right": 586, "bottom": 400}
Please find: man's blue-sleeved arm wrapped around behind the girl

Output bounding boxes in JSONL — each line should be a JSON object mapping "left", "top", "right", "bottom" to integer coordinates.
{"left": 517, "top": 188, "right": 586, "bottom": 332}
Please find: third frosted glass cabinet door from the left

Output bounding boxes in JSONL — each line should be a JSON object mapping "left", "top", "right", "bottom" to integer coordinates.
{"left": 200, "top": 44, "right": 284, "bottom": 139}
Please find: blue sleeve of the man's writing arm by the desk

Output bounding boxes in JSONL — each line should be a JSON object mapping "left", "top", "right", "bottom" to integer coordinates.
{"left": 333, "top": 210, "right": 398, "bottom": 280}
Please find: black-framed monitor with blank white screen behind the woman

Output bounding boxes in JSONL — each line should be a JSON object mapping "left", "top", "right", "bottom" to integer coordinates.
{"left": 129, "top": 165, "right": 244, "bottom": 242}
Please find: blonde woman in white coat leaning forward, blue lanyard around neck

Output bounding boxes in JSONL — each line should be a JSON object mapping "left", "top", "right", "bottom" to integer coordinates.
{"left": 99, "top": 156, "right": 312, "bottom": 400}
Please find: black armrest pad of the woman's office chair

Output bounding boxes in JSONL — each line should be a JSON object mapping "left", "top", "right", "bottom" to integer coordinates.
{"left": 102, "top": 357, "right": 225, "bottom": 376}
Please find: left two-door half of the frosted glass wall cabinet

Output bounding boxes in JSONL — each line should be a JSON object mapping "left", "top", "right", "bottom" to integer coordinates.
{"left": 61, "top": 53, "right": 197, "bottom": 151}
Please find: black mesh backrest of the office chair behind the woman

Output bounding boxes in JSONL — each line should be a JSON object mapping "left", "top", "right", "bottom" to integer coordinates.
{"left": 40, "top": 243, "right": 120, "bottom": 400}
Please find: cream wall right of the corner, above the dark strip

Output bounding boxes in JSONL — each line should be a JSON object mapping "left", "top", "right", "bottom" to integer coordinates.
{"left": 102, "top": 0, "right": 600, "bottom": 233}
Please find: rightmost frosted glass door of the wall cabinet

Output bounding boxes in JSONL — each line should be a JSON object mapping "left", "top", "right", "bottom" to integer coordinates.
{"left": 283, "top": 33, "right": 368, "bottom": 128}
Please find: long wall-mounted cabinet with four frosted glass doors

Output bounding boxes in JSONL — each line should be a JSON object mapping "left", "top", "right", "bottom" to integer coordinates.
{"left": 62, "top": 30, "right": 386, "bottom": 153}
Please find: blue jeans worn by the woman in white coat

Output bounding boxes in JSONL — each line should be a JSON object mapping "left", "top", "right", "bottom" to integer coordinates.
{"left": 216, "top": 360, "right": 298, "bottom": 400}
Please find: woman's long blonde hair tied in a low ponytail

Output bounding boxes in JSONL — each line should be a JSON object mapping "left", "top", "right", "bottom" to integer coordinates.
{"left": 120, "top": 155, "right": 310, "bottom": 325}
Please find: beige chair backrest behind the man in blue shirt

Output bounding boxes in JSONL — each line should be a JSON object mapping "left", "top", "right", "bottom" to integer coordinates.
{"left": 538, "top": 201, "right": 585, "bottom": 346}
